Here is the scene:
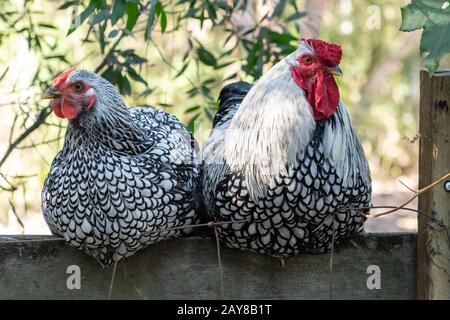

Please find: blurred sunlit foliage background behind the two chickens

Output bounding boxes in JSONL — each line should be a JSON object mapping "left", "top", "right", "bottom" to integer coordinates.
{"left": 0, "top": 0, "right": 450, "bottom": 233}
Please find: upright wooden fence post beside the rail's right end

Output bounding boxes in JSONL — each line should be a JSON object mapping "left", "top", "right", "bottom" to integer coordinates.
{"left": 417, "top": 70, "right": 450, "bottom": 299}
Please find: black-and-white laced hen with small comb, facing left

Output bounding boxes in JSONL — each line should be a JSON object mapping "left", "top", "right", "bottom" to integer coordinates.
{"left": 42, "top": 68, "right": 200, "bottom": 266}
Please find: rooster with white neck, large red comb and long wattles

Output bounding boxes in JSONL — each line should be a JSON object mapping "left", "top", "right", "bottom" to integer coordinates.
{"left": 202, "top": 39, "right": 371, "bottom": 260}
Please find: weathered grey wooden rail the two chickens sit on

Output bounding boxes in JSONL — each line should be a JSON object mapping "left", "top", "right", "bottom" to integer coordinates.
{"left": 0, "top": 234, "right": 416, "bottom": 299}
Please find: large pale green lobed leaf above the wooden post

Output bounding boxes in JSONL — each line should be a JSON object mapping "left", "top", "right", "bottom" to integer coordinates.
{"left": 400, "top": 0, "right": 450, "bottom": 75}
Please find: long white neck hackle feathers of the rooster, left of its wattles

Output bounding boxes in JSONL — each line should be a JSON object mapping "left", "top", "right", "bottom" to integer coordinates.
{"left": 223, "top": 42, "right": 315, "bottom": 198}
